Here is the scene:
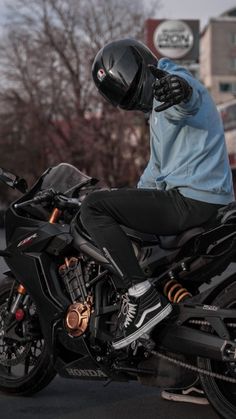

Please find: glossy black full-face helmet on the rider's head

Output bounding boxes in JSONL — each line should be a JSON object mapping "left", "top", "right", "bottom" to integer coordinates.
{"left": 92, "top": 39, "right": 157, "bottom": 112}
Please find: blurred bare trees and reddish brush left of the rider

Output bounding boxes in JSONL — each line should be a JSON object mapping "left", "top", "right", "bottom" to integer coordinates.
{"left": 0, "top": 0, "right": 160, "bottom": 190}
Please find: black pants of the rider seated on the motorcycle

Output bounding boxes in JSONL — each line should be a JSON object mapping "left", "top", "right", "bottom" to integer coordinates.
{"left": 81, "top": 189, "right": 220, "bottom": 288}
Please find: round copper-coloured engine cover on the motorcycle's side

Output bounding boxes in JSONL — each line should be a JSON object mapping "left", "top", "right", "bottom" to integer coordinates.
{"left": 65, "top": 302, "right": 91, "bottom": 337}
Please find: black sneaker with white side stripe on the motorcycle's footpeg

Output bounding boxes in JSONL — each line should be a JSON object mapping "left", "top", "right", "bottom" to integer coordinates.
{"left": 112, "top": 286, "right": 172, "bottom": 349}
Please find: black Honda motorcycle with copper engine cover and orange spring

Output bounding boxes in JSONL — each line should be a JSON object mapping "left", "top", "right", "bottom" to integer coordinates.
{"left": 0, "top": 163, "right": 236, "bottom": 419}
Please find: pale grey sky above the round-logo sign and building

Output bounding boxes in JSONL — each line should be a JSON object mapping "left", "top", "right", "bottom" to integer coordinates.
{"left": 157, "top": 0, "right": 236, "bottom": 29}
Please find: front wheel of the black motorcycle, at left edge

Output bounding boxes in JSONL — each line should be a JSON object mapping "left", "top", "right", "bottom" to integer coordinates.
{"left": 0, "top": 278, "right": 56, "bottom": 396}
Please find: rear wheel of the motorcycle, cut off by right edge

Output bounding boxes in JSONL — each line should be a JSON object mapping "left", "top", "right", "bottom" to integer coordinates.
{"left": 198, "top": 283, "right": 236, "bottom": 419}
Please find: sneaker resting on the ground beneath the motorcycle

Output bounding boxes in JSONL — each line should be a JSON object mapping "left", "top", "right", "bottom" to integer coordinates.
{"left": 161, "top": 379, "right": 209, "bottom": 405}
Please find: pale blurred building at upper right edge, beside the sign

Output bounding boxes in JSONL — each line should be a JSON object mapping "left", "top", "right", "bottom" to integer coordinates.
{"left": 200, "top": 8, "right": 236, "bottom": 103}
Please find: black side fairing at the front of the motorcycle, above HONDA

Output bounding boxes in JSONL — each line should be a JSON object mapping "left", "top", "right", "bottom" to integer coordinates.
{"left": 3, "top": 223, "right": 72, "bottom": 348}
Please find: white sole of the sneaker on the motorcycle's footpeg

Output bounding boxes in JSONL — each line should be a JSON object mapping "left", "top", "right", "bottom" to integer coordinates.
{"left": 112, "top": 304, "right": 172, "bottom": 349}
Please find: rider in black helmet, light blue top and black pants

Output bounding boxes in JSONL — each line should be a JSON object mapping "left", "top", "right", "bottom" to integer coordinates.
{"left": 81, "top": 39, "right": 233, "bottom": 349}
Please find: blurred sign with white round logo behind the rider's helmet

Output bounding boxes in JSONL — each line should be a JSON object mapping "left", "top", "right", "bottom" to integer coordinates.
{"left": 146, "top": 19, "right": 199, "bottom": 62}
